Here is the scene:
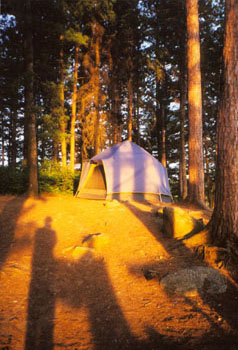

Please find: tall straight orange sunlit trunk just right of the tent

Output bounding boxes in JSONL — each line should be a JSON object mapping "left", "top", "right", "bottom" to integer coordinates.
{"left": 187, "top": 0, "right": 204, "bottom": 206}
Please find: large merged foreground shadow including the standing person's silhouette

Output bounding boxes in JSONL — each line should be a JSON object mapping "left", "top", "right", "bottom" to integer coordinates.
{"left": 25, "top": 217, "right": 185, "bottom": 350}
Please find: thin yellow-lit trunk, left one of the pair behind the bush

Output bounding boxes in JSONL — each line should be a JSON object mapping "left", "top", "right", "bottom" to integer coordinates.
{"left": 60, "top": 35, "right": 67, "bottom": 168}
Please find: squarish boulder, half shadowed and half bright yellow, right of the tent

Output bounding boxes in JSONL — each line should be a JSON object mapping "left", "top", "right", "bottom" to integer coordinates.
{"left": 162, "top": 207, "right": 204, "bottom": 239}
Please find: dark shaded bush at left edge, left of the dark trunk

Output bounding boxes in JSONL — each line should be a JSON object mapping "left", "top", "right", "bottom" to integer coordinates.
{"left": 0, "top": 166, "right": 28, "bottom": 195}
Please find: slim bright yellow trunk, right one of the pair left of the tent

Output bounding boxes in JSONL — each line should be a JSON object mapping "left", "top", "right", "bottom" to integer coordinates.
{"left": 70, "top": 45, "right": 79, "bottom": 172}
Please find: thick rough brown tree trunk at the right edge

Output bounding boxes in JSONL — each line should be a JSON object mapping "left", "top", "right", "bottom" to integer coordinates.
{"left": 210, "top": 0, "right": 238, "bottom": 250}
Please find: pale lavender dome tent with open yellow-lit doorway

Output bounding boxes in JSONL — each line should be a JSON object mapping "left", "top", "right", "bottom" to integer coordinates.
{"left": 76, "top": 141, "right": 172, "bottom": 202}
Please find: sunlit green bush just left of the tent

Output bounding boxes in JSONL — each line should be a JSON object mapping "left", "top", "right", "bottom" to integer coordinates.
{"left": 39, "top": 160, "right": 80, "bottom": 194}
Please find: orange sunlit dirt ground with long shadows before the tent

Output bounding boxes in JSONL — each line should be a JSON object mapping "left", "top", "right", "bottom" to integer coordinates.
{"left": 0, "top": 196, "right": 238, "bottom": 350}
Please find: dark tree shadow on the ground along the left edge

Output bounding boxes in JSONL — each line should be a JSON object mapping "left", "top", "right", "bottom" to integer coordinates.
{"left": 0, "top": 196, "right": 30, "bottom": 270}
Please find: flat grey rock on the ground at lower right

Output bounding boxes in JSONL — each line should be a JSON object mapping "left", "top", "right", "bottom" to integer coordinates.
{"left": 160, "top": 266, "right": 227, "bottom": 296}
